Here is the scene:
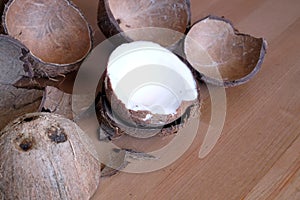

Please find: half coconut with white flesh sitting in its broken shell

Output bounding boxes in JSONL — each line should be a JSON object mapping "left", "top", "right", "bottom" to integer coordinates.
{"left": 97, "top": 41, "right": 199, "bottom": 137}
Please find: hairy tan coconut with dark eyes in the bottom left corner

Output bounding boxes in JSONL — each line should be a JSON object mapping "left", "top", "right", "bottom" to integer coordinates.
{"left": 0, "top": 113, "right": 101, "bottom": 200}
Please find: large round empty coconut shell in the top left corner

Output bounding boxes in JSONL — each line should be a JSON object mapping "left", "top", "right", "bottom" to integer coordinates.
{"left": 3, "top": 0, "right": 92, "bottom": 77}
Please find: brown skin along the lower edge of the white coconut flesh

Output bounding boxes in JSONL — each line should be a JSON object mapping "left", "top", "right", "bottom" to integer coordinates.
{"left": 104, "top": 72, "right": 198, "bottom": 128}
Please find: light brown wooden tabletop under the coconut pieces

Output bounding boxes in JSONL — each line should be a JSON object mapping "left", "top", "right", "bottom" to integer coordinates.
{"left": 75, "top": 0, "right": 300, "bottom": 200}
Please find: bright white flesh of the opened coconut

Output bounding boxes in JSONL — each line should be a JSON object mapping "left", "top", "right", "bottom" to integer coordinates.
{"left": 107, "top": 41, "right": 197, "bottom": 115}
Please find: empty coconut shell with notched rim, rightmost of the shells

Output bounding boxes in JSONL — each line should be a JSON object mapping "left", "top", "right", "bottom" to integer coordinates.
{"left": 184, "top": 16, "right": 267, "bottom": 87}
